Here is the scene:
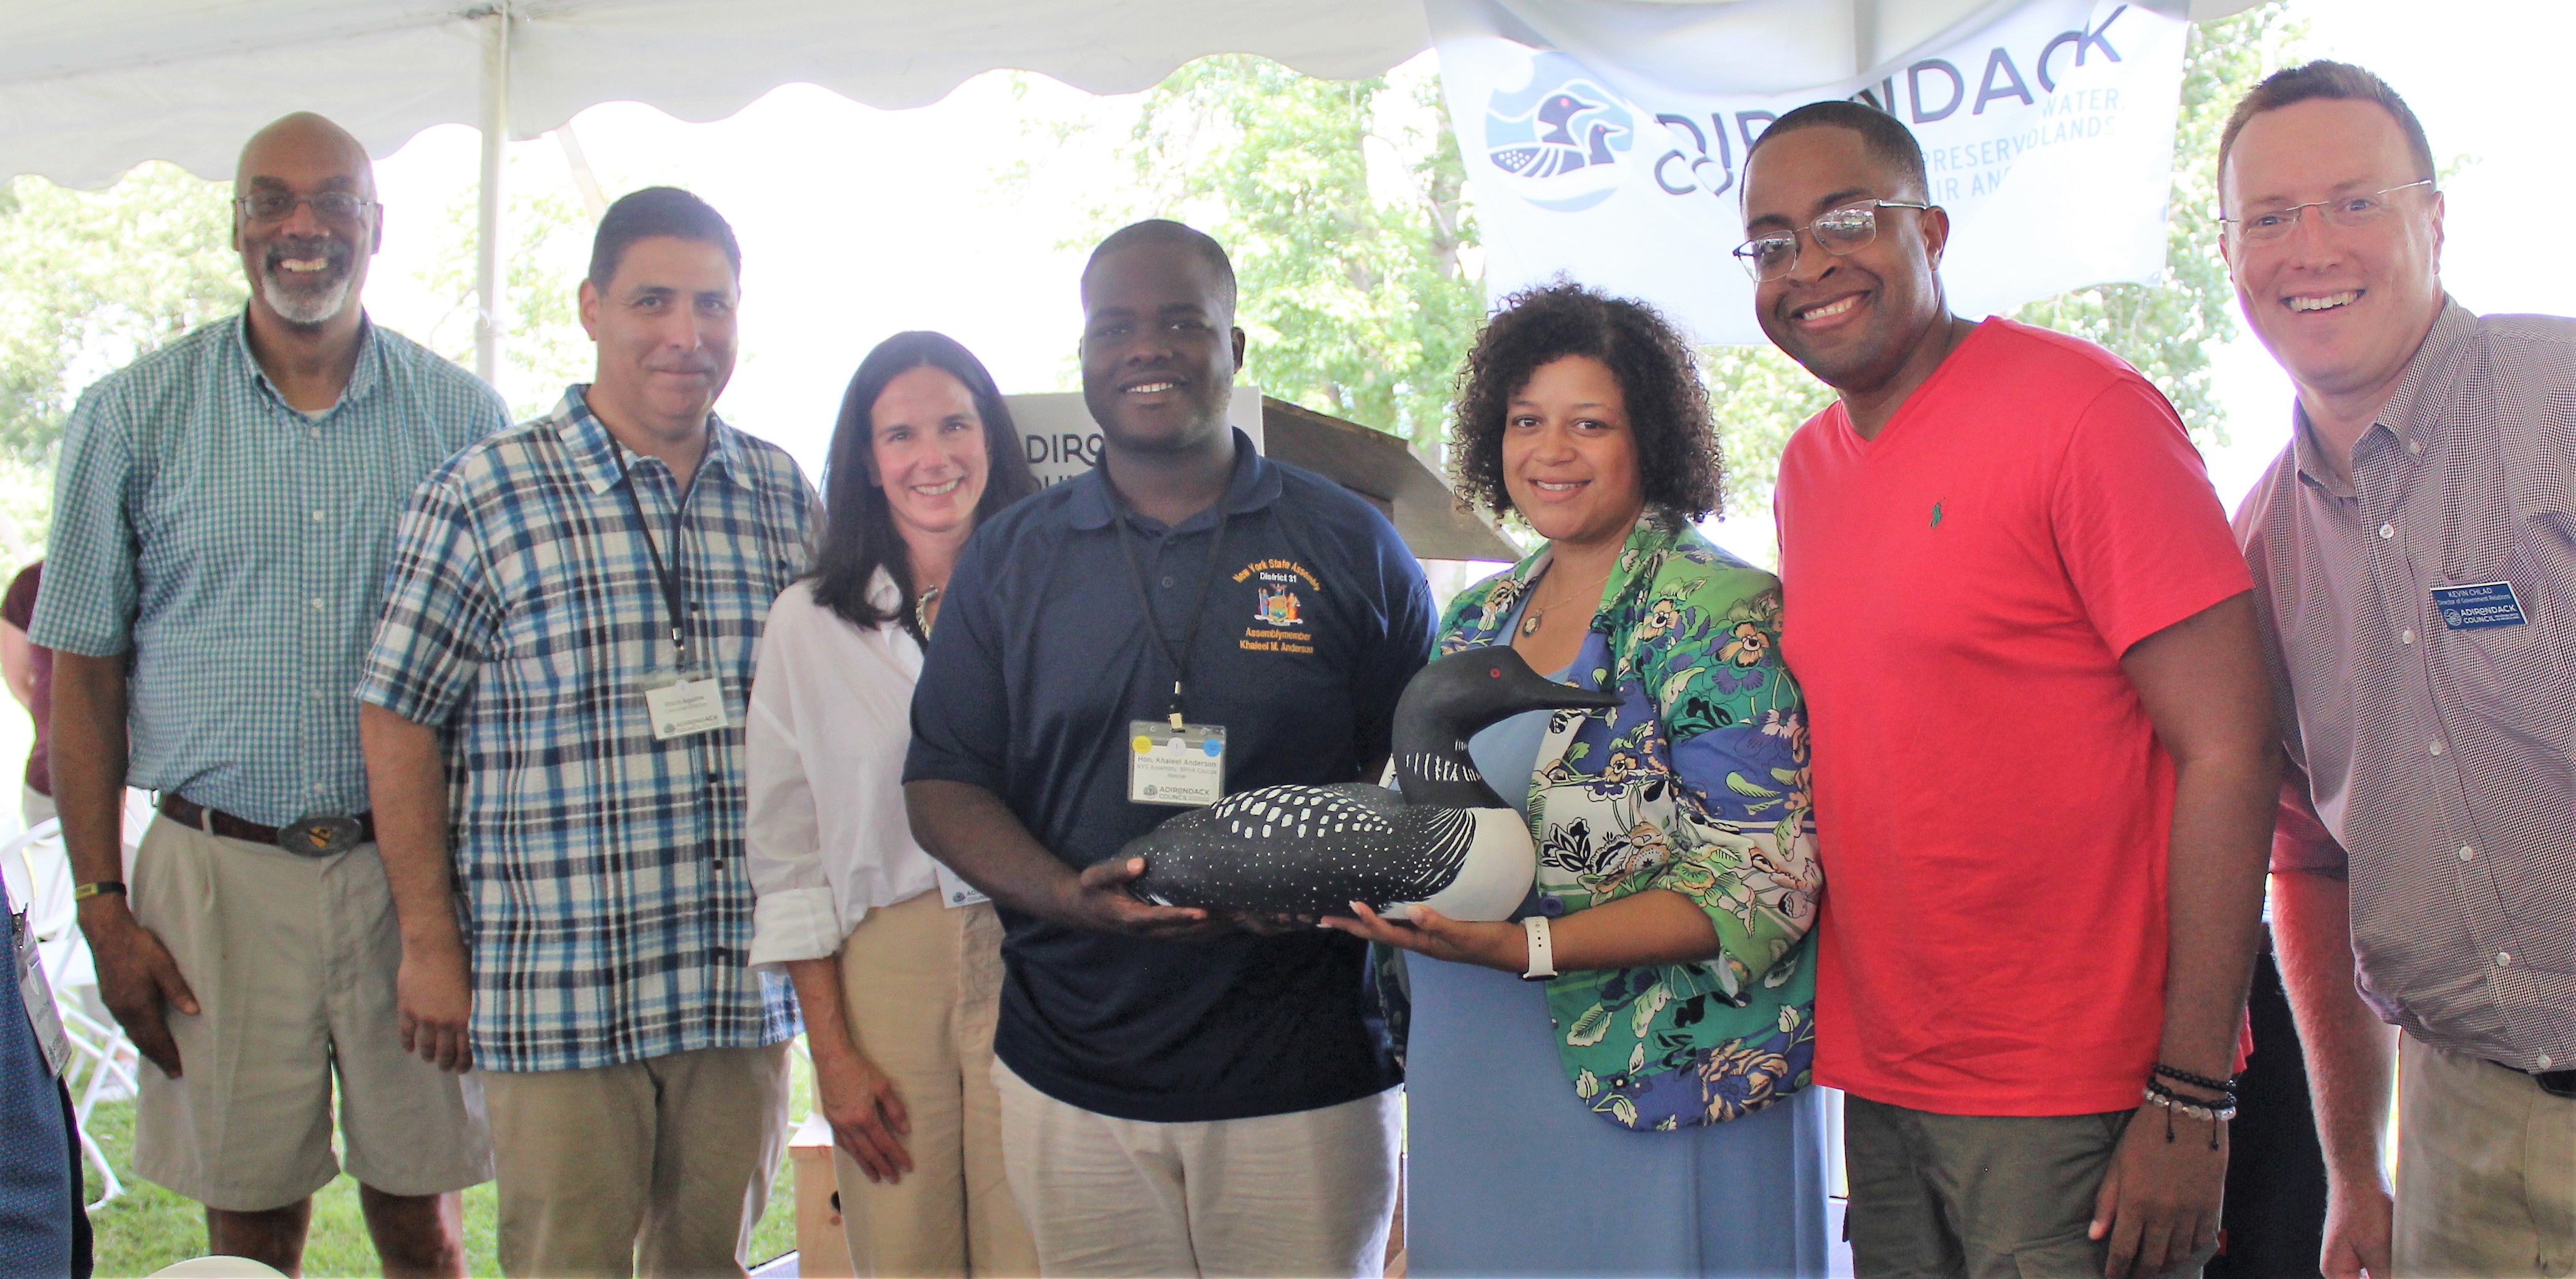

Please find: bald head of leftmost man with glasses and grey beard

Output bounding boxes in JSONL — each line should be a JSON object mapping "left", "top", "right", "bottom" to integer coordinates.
{"left": 232, "top": 111, "right": 384, "bottom": 340}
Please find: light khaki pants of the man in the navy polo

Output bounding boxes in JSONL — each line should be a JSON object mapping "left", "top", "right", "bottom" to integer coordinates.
{"left": 991, "top": 1063, "right": 1401, "bottom": 1279}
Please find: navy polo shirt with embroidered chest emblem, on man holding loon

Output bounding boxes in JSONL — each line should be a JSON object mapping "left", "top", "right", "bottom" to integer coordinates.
{"left": 904, "top": 433, "right": 1432, "bottom": 1122}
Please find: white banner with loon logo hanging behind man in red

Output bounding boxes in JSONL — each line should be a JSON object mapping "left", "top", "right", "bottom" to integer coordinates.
{"left": 1427, "top": 0, "right": 2189, "bottom": 343}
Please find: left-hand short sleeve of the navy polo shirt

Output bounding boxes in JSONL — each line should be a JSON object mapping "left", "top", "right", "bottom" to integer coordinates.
{"left": 904, "top": 534, "right": 1010, "bottom": 794}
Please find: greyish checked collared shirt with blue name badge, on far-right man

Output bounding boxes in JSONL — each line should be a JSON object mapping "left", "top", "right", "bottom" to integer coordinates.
{"left": 2236, "top": 302, "right": 2576, "bottom": 1070}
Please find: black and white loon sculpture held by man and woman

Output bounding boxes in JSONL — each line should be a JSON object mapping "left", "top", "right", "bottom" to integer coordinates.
{"left": 1118, "top": 647, "right": 1620, "bottom": 920}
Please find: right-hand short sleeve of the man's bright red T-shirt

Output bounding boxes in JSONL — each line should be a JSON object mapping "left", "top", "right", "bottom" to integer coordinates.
{"left": 2050, "top": 379, "right": 2254, "bottom": 655}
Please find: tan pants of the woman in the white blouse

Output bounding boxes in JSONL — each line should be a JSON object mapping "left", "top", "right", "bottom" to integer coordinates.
{"left": 832, "top": 892, "right": 1038, "bottom": 1277}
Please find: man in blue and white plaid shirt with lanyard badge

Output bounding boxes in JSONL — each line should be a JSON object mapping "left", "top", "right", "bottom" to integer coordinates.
{"left": 358, "top": 188, "right": 817, "bottom": 1277}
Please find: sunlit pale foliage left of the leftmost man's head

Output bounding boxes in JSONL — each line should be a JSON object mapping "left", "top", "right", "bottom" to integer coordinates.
{"left": 0, "top": 163, "right": 250, "bottom": 464}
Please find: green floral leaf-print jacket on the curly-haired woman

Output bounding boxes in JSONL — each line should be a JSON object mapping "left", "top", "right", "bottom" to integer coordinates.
{"left": 1440, "top": 511, "right": 1824, "bottom": 1129}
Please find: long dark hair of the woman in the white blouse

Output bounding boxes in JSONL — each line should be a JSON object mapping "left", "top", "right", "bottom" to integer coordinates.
{"left": 809, "top": 330, "right": 1038, "bottom": 640}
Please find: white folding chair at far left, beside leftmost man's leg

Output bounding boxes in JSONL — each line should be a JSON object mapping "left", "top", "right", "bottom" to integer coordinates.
{"left": 0, "top": 820, "right": 137, "bottom": 1212}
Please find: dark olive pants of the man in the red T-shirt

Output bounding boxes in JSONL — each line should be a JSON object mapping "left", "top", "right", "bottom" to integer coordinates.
{"left": 1842, "top": 1096, "right": 2218, "bottom": 1279}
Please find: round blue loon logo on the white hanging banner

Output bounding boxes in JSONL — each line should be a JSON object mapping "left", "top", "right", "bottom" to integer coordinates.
{"left": 1483, "top": 54, "right": 1636, "bottom": 214}
